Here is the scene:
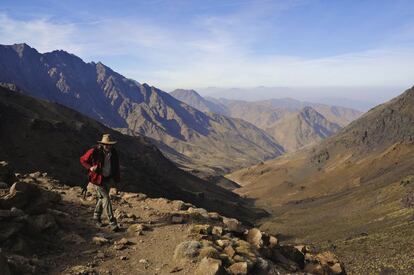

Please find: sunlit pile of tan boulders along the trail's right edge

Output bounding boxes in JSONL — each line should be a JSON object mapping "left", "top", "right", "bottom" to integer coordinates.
{"left": 171, "top": 207, "right": 346, "bottom": 275}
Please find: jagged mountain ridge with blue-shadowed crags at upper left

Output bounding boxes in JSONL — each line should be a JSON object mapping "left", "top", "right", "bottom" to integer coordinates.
{"left": 0, "top": 44, "right": 283, "bottom": 174}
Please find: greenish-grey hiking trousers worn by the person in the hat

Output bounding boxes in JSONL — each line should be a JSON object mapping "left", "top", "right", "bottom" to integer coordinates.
{"left": 93, "top": 179, "right": 117, "bottom": 225}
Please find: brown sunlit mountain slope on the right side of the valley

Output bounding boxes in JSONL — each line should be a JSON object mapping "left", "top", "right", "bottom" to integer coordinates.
{"left": 229, "top": 85, "right": 414, "bottom": 274}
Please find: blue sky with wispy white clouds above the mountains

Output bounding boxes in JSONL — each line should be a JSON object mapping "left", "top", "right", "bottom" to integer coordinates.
{"left": 0, "top": 0, "right": 414, "bottom": 98}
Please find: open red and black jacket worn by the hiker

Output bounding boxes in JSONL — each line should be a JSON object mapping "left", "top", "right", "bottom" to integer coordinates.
{"left": 80, "top": 145, "right": 121, "bottom": 185}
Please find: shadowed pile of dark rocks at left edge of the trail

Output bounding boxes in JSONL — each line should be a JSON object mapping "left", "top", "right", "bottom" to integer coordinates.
{"left": 0, "top": 162, "right": 60, "bottom": 274}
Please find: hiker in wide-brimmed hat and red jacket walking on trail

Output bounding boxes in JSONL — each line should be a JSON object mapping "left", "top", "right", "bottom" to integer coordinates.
{"left": 80, "top": 134, "right": 120, "bottom": 231}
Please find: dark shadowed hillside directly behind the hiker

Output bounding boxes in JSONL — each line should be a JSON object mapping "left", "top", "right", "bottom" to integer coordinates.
{"left": 0, "top": 87, "right": 264, "bottom": 224}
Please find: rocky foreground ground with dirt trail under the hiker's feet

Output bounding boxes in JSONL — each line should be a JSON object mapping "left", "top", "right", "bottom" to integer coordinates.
{"left": 0, "top": 162, "right": 345, "bottom": 275}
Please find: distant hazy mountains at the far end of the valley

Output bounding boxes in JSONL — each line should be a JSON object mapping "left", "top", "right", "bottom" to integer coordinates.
{"left": 171, "top": 90, "right": 350, "bottom": 152}
